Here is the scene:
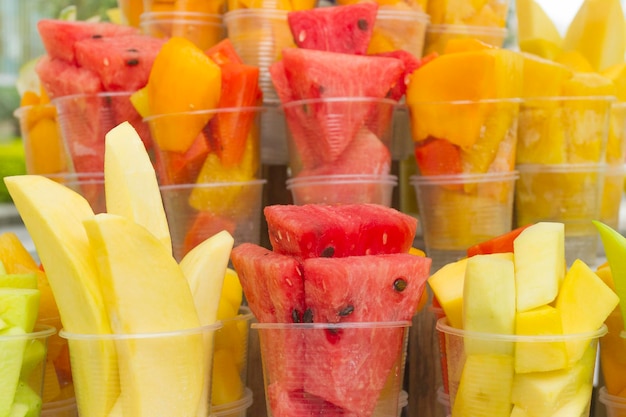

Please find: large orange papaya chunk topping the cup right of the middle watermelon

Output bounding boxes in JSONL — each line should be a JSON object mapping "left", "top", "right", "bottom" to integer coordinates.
{"left": 406, "top": 48, "right": 523, "bottom": 148}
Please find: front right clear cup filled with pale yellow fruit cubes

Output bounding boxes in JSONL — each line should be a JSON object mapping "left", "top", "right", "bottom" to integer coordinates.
{"left": 429, "top": 222, "right": 619, "bottom": 416}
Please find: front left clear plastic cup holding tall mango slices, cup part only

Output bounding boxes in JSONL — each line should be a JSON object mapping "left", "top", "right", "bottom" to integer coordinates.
{"left": 59, "top": 323, "right": 221, "bottom": 417}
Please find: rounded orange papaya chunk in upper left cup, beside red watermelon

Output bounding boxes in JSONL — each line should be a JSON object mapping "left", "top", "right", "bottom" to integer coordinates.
{"left": 147, "top": 37, "right": 222, "bottom": 152}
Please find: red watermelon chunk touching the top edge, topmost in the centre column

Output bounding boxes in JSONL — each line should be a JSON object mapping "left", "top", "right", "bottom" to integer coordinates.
{"left": 287, "top": 3, "right": 378, "bottom": 55}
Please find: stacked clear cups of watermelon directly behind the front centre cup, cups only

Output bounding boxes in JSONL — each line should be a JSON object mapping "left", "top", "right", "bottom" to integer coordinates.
{"left": 282, "top": 97, "right": 397, "bottom": 206}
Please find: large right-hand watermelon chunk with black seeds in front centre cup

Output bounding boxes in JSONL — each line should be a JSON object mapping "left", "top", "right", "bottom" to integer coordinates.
{"left": 303, "top": 254, "right": 431, "bottom": 416}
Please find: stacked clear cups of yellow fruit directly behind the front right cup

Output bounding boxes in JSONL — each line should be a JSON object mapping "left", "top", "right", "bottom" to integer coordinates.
{"left": 515, "top": 96, "right": 623, "bottom": 265}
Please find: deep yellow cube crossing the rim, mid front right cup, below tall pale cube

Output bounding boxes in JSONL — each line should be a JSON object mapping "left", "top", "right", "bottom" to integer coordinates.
{"left": 515, "top": 305, "right": 567, "bottom": 373}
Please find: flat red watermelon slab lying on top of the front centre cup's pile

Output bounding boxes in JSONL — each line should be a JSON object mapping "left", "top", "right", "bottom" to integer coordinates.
{"left": 264, "top": 204, "right": 417, "bottom": 259}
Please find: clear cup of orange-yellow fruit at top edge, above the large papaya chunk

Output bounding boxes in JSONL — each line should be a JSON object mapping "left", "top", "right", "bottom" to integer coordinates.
{"left": 424, "top": 0, "right": 509, "bottom": 54}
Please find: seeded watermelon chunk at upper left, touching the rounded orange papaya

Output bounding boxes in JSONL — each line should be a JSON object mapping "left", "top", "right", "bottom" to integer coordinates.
{"left": 75, "top": 35, "right": 165, "bottom": 91}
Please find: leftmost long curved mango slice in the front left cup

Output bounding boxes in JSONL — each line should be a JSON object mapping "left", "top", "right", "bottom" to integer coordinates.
{"left": 4, "top": 175, "right": 118, "bottom": 417}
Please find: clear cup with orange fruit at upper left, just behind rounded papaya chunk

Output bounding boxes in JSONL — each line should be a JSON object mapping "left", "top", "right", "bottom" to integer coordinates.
{"left": 140, "top": 12, "right": 226, "bottom": 50}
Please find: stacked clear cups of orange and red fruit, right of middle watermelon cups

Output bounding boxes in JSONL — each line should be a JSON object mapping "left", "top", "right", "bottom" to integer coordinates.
{"left": 410, "top": 98, "right": 520, "bottom": 273}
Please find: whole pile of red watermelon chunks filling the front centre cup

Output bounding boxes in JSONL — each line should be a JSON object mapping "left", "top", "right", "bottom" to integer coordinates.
{"left": 231, "top": 205, "right": 430, "bottom": 416}
